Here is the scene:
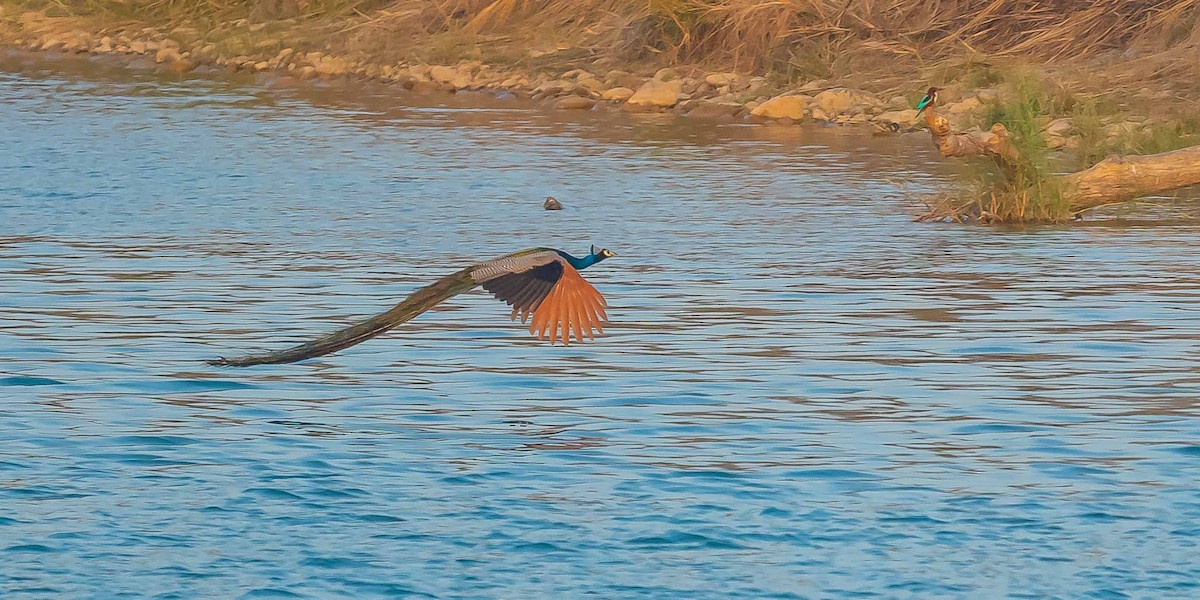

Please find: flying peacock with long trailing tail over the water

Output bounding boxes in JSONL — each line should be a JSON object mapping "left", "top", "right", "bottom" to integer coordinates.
{"left": 206, "top": 246, "right": 617, "bottom": 367}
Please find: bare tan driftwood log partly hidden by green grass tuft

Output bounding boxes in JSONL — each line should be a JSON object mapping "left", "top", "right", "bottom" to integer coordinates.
{"left": 925, "top": 107, "right": 1200, "bottom": 215}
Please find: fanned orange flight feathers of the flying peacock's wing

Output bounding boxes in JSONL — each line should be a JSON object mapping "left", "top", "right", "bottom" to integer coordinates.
{"left": 529, "top": 264, "right": 608, "bottom": 346}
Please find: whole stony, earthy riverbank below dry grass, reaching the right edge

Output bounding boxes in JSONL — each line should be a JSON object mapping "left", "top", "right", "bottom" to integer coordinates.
{"left": 0, "top": 1, "right": 1200, "bottom": 157}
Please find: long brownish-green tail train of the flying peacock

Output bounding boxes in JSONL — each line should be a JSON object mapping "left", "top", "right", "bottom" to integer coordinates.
{"left": 205, "top": 269, "right": 476, "bottom": 367}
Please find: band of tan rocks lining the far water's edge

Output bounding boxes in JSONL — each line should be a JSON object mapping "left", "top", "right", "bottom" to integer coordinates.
{"left": 0, "top": 6, "right": 1161, "bottom": 149}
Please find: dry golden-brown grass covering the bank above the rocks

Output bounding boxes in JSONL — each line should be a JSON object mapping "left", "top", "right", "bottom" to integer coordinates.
{"left": 16, "top": 0, "right": 1200, "bottom": 85}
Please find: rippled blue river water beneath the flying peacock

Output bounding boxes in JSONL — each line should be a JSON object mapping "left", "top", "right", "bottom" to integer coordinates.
{"left": 0, "top": 55, "right": 1200, "bottom": 599}
